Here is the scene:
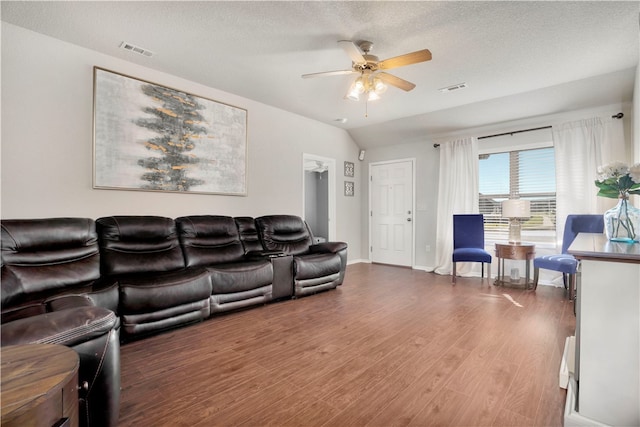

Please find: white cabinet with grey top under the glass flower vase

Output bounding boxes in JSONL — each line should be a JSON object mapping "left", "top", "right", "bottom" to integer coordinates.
{"left": 564, "top": 233, "right": 640, "bottom": 427}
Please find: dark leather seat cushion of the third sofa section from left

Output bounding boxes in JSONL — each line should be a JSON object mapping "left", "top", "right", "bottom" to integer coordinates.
{"left": 207, "top": 259, "right": 273, "bottom": 295}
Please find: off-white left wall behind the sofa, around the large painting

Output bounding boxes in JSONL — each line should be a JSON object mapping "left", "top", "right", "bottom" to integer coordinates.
{"left": 1, "top": 23, "right": 361, "bottom": 259}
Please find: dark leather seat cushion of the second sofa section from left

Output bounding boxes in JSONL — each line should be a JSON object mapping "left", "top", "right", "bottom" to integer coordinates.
{"left": 117, "top": 268, "right": 211, "bottom": 314}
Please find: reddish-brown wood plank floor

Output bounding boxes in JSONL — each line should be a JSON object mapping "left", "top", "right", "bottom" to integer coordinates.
{"left": 120, "top": 264, "right": 575, "bottom": 426}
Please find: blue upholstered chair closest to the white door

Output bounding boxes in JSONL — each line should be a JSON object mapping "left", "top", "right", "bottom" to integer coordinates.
{"left": 451, "top": 214, "right": 491, "bottom": 283}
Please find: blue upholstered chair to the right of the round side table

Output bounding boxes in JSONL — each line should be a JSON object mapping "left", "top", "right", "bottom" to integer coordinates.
{"left": 533, "top": 215, "right": 604, "bottom": 300}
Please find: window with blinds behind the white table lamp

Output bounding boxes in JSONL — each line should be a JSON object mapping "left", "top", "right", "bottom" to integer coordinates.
{"left": 479, "top": 147, "right": 556, "bottom": 244}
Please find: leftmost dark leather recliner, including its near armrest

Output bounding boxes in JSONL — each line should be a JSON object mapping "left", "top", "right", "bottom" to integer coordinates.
{"left": 1, "top": 218, "right": 120, "bottom": 427}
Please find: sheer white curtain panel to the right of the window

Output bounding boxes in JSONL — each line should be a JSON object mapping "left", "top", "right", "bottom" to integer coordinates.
{"left": 552, "top": 117, "right": 628, "bottom": 244}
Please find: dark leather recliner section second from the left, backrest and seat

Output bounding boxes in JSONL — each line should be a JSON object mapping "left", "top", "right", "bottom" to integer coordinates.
{"left": 96, "top": 216, "right": 211, "bottom": 339}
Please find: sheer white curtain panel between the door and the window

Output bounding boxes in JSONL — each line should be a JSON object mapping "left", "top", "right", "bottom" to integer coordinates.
{"left": 434, "top": 138, "right": 480, "bottom": 276}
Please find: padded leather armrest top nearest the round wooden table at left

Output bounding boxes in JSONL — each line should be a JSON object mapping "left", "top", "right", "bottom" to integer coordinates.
{"left": 2, "top": 305, "right": 119, "bottom": 346}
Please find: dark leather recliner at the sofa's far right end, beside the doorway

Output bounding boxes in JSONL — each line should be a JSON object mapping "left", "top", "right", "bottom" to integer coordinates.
{"left": 255, "top": 215, "right": 347, "bottom": 296}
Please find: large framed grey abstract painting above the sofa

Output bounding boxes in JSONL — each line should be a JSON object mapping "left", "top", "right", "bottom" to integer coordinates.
{"left": 93, "top": 67, "right": 248, "bottom": 196}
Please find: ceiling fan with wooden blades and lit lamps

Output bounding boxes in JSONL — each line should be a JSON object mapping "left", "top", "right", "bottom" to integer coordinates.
{"left": 302, "top": 40, "right": 431, "bottom": 101}
